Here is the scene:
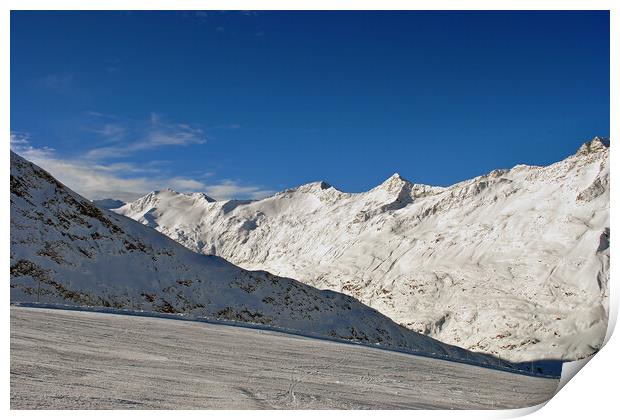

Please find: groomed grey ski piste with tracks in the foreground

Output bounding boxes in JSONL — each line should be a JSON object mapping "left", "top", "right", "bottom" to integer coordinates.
{"left": 11, "top": 307, "right": 558, "bottom": 409}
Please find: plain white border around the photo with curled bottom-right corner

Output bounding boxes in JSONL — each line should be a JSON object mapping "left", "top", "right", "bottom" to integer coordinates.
{"left": 0, "top": 0, "right": 620, "bottom": 420}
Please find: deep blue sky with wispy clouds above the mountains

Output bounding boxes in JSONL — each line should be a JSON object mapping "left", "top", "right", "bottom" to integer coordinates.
{"left": 11, "top": 11, "right": 609, "bottom": 200}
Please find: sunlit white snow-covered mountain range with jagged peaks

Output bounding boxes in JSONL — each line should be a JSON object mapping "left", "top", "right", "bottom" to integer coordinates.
{"left": 115, "top": 138, "right": 609, "bottom": 361}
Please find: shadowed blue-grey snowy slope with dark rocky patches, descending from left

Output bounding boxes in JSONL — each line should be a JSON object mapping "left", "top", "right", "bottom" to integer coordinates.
{"left": 11, "top": 153, "right": 524, "bottom": 366}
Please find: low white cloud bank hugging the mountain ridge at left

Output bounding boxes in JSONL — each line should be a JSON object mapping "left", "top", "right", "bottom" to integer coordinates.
{"left": 11, "top": 132, "right": 273, "bottom": 201}
